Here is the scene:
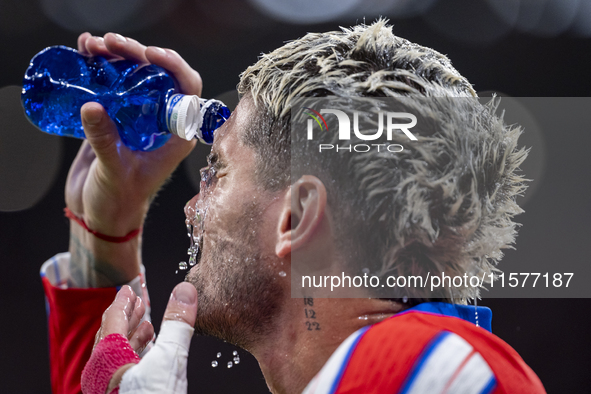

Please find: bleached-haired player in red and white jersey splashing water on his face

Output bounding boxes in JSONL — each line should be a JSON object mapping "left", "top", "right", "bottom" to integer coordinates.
{"left": 42, "top": 20, "right": 544, "bottom": 393}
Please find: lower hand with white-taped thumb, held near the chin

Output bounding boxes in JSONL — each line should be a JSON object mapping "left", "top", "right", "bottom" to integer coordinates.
{"left": 82, "top": 282, "right": 197, "bottom": 393}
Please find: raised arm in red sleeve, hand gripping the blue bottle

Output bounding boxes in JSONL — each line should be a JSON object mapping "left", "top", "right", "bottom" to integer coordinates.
{"left": 41, "top": 33, "right": 201, "bottom": 394}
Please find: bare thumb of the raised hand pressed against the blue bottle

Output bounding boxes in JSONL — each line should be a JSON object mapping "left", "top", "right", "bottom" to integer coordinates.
{"left": 80, "top": 102, "right": 121, "bottom": 164}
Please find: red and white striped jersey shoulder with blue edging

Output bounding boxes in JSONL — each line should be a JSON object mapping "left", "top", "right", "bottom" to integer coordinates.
{"left": 307, "top": 311, "right": 545, "bottom": 394}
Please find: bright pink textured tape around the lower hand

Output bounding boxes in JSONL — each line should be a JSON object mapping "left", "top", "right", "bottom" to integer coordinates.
{"left": 81, "top": 334, "right": 140, "bottom": 394}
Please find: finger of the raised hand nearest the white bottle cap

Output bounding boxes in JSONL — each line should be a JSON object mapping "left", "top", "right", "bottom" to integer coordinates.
{"left": 145, "top": 47, "right": 203, "bottom": 96}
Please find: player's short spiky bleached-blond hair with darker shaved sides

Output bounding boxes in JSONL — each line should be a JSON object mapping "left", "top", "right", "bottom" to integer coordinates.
{"left": 238, "top": 19, "right": 527, "bottom": 302}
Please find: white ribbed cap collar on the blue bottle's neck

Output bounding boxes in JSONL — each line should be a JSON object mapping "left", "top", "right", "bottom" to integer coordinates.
{"left": 166, "top": 94, "right": 203, "bottom": 141}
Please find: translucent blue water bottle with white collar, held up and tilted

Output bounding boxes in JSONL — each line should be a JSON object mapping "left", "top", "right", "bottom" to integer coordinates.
{"left": 21, "top": 46, "right": 230, "bottom": 151}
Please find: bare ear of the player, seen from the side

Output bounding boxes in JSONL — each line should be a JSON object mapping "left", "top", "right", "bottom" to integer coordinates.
{"left": 275, "top": 175, "right": 326, "bottom": 258}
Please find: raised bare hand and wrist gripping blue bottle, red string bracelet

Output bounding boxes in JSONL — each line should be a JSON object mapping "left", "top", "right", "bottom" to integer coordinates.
{"left": 66, "top": 33, "right": 202, "bottom": 287}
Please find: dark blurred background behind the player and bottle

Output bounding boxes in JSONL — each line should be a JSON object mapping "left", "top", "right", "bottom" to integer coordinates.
{"left": 0, "top": 0, "right": 591, "bottom": 393}
